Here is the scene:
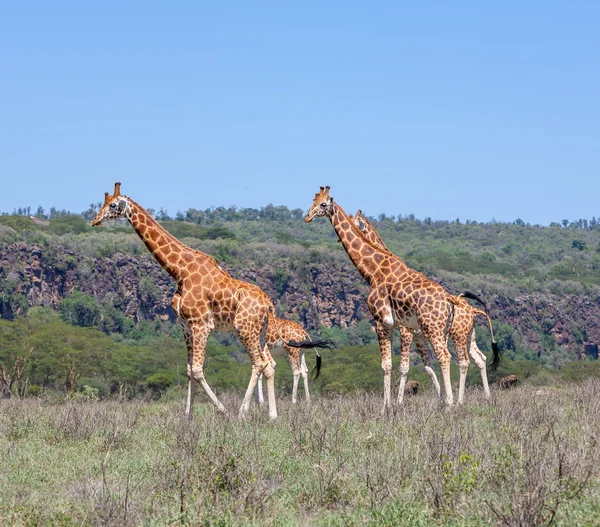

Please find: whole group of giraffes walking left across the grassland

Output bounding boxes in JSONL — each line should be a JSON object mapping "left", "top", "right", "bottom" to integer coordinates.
{"left": 92, "top": 183, "right": 500, "bottom": 419}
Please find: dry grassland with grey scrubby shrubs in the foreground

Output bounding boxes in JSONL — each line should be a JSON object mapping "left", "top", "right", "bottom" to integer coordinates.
{"left": 0, "top": 379, "right": 600, "bottom": 526}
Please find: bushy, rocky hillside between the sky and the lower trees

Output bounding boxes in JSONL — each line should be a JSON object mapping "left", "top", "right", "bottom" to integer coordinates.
{"left": 0, "top": 206, "right": 600, "bottom": 396}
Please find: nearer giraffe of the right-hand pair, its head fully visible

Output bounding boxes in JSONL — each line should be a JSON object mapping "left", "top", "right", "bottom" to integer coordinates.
{"left": 304, "top": 187, "right": 496, "bottom": 410}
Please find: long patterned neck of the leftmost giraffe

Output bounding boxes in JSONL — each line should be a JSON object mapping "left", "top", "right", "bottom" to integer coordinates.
{"left": 127, "top": 198, "right": 195, "bottom": 285}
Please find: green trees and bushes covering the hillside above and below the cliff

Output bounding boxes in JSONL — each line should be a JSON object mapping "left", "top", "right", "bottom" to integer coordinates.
{"left": 0, "top": 204, "right": 600, "bottom": 398}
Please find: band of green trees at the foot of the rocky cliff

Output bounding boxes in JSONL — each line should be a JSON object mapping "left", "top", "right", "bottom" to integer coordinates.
{"left": 0, "top": 306, "right": 600, "bottom": 398}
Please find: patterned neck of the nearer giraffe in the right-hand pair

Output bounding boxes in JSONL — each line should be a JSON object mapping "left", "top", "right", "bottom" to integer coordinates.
{"left": 329, "top": 203, "right": 393, "bottom": 286}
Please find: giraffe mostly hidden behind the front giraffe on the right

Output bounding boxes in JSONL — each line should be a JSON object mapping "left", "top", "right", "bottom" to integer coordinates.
{"left": 350, "top": 210, "right": 499, "bottom": 404}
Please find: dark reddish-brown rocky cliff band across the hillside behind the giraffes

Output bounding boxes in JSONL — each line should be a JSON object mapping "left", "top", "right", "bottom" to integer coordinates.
{"left": 0, "top": 242, "right": 600, "bottom": 357}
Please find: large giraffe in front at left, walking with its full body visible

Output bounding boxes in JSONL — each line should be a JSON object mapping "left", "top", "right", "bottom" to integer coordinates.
{"left": 92, "top": 183, "right": 328, "bottom": 419}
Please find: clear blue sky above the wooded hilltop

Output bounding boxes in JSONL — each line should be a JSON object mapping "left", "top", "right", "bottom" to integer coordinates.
{"left": 0, "top": 1, "right": 600, "bottom": 225}
